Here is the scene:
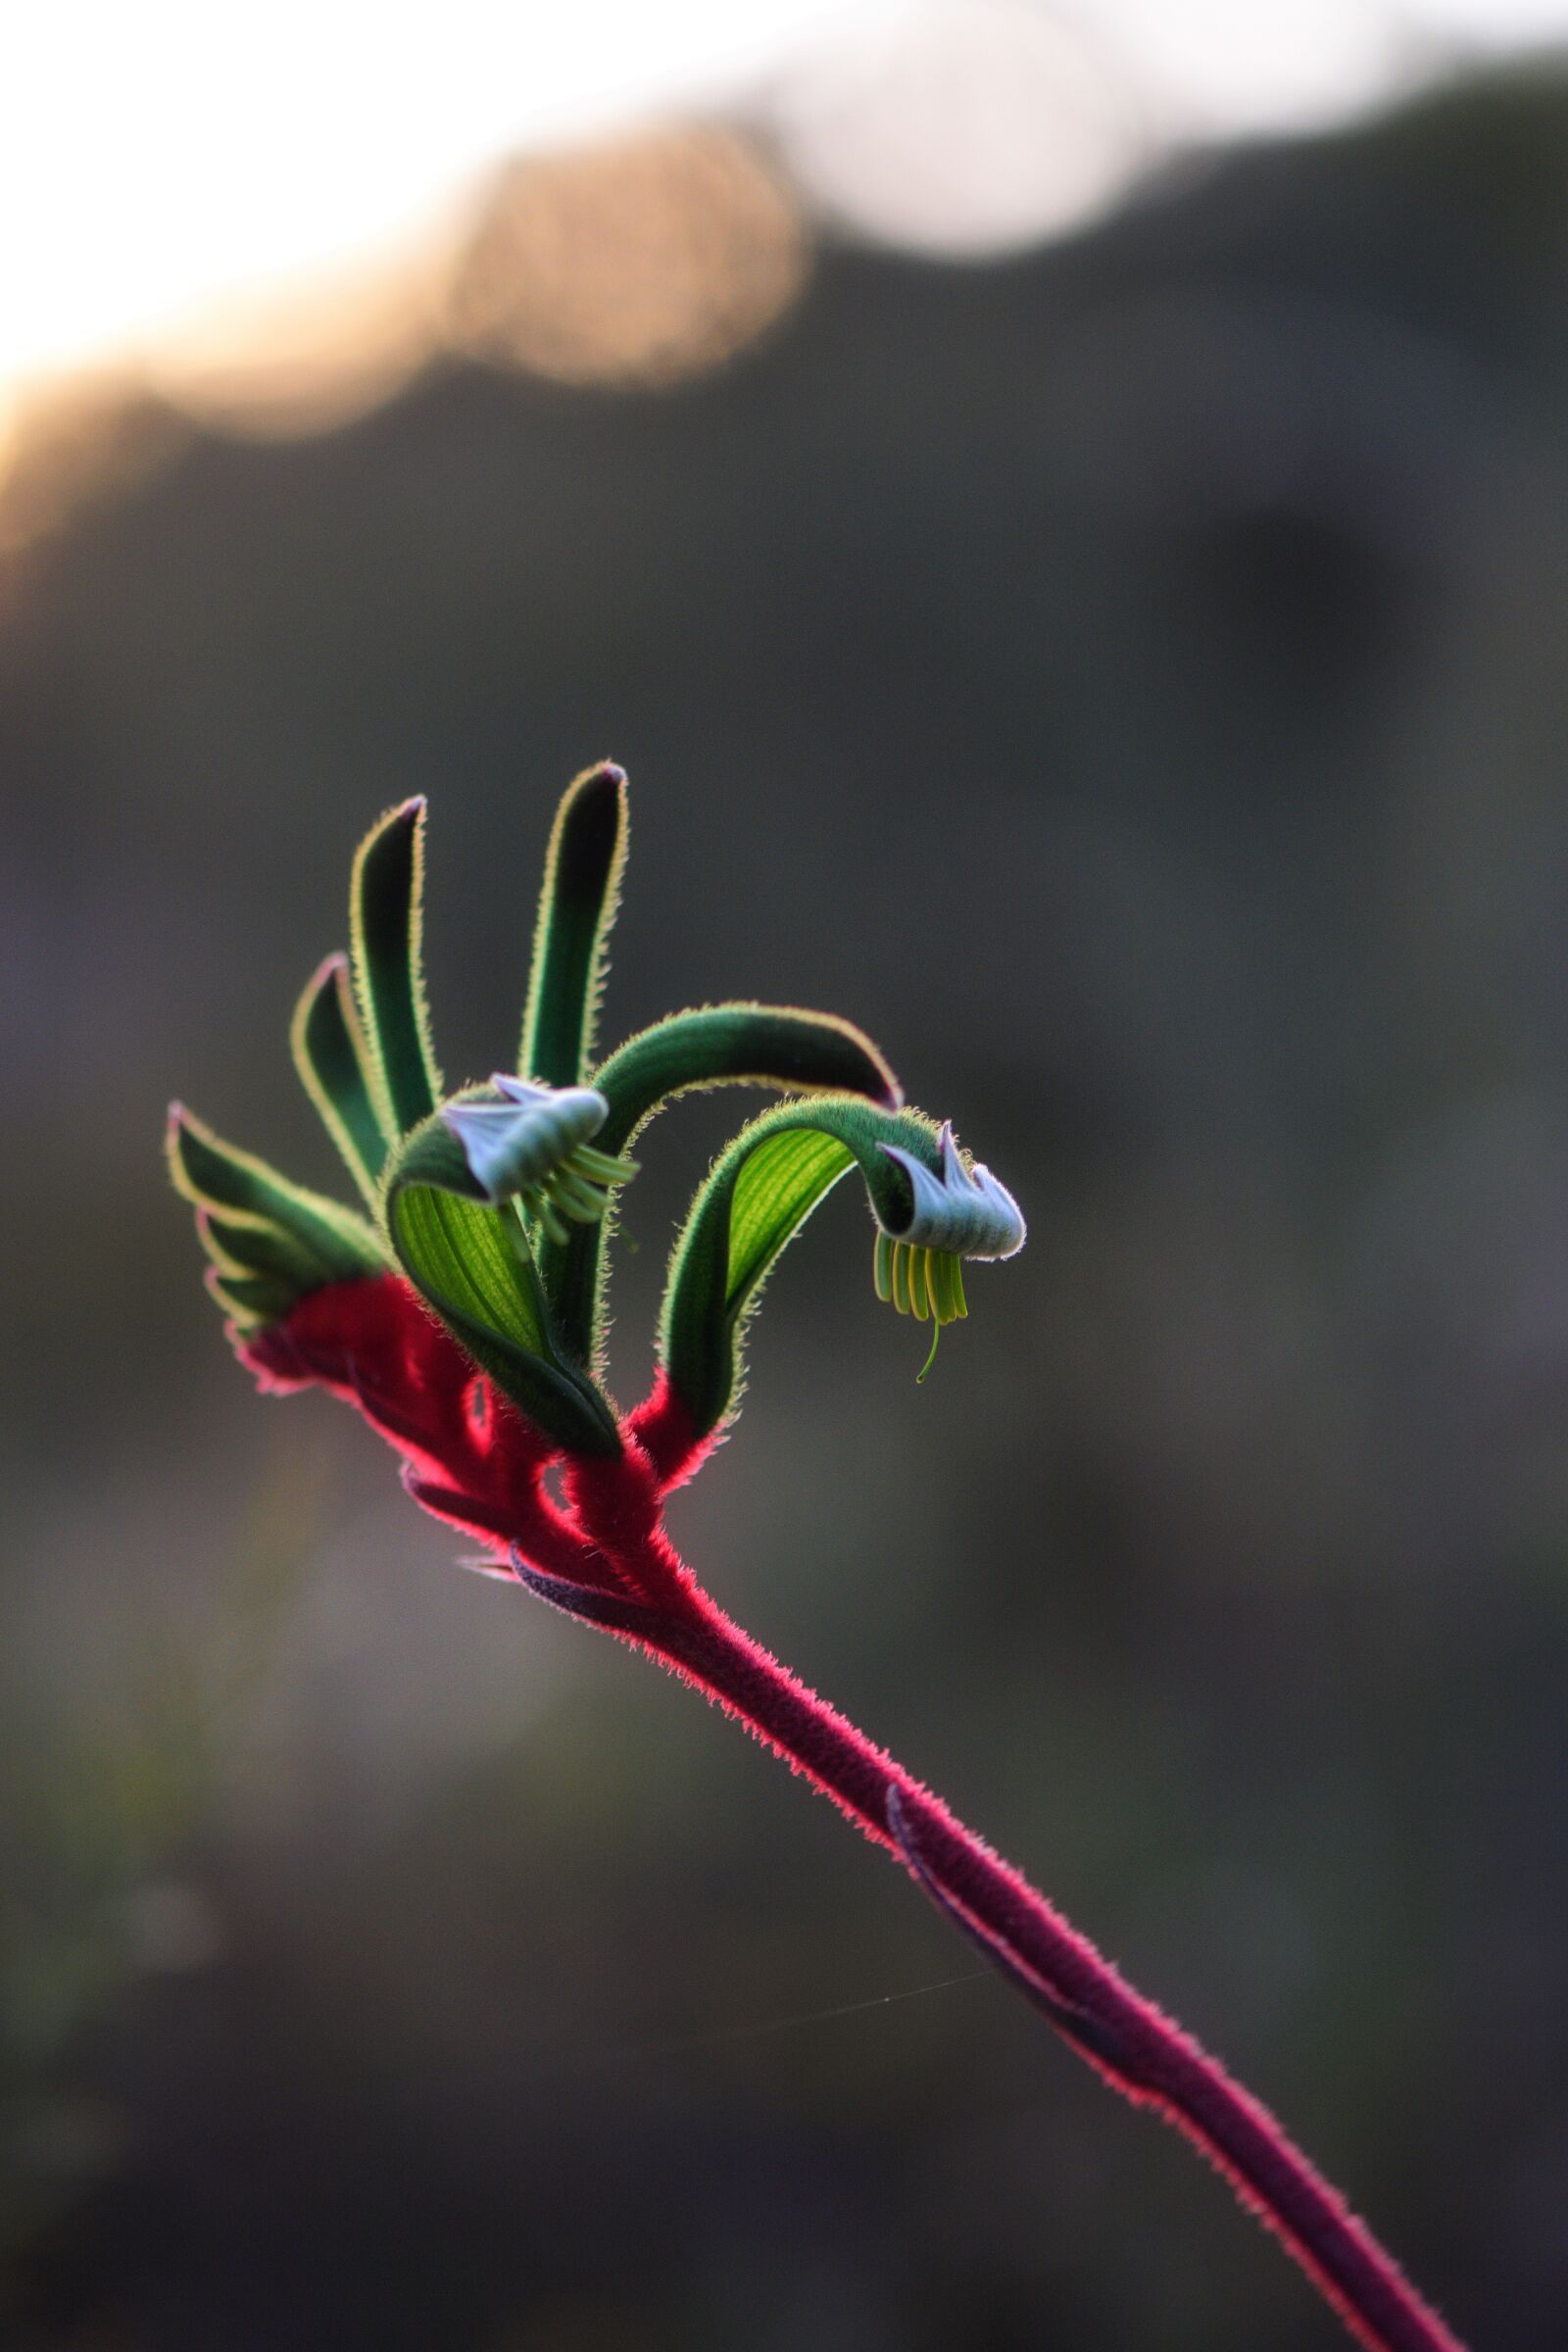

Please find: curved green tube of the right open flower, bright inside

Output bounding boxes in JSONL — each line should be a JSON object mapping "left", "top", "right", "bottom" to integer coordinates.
{"left": 661, "top": 1096, "right": 941, "bottom": 1437}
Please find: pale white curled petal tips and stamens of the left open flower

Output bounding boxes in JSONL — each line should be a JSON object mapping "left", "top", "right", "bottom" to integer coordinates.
{"left": 442, "top": 1070, "right": 637, "bottom": 1249}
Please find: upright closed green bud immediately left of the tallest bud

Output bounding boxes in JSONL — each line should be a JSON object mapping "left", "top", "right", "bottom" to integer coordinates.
{"left": 348, "top": 798, "right": 442, "bottom": 1136}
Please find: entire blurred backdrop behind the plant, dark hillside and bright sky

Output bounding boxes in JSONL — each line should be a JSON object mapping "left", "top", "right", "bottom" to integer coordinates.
{"left": 0, "top": 0, "right": 1568, "bottom": 2352}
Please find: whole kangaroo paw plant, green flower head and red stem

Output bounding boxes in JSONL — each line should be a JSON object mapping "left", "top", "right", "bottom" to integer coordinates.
{"left": 170, "top": 764, "right": 1460, "bottom": 2352}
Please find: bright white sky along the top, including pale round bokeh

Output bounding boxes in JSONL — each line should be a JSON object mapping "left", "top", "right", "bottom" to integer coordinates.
{"left": 0, "top": 0, "right": 1568, "bottom": 395}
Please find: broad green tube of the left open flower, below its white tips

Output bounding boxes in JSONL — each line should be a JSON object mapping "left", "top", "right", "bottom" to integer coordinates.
{"left": 383, "top": 1105, "right": 620, "bottom": 1453}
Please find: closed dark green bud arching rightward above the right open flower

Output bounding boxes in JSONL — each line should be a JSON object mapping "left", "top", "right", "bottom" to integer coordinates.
{"left": 541, "top": 1004, "right": 903, "bottom": 1364}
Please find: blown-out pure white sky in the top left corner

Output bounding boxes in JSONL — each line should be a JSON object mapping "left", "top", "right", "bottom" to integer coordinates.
{"left": 0, "top": 0, "right": 859, "bottom": 378}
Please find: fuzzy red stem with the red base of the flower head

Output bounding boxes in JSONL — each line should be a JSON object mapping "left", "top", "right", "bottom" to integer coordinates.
{"left": 242, "top": 1307, "right": 1462, "bottom": 2352}
